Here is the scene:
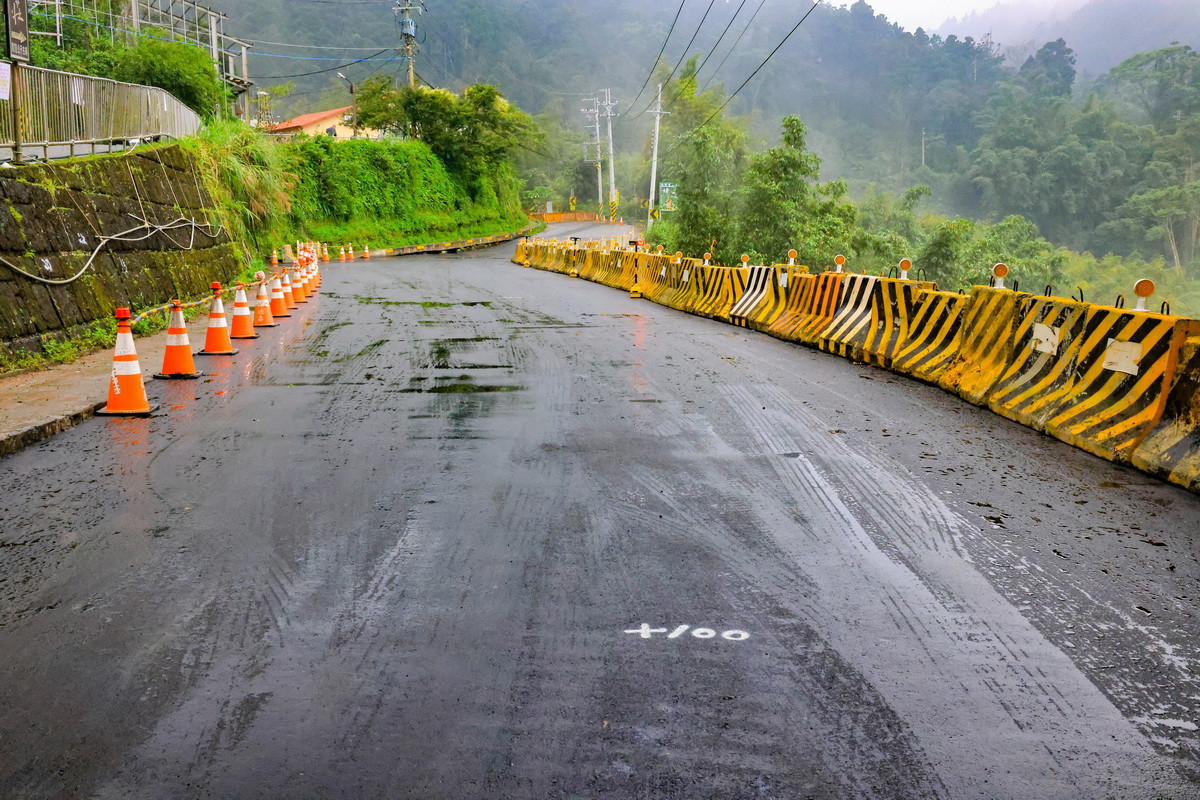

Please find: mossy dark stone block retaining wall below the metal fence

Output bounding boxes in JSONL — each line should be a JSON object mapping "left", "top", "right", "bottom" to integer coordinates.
{"left": 0, "top": 145, "right": 244, "bottom": 349}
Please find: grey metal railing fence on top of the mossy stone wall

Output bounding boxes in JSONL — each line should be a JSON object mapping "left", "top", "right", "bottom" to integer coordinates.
{"left": 0, "top": 62, "right": 200, "bottom": 161}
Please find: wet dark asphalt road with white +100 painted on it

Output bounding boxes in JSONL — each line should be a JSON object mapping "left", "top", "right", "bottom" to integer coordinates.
{"left": 0, "top": 220, "right": 1200, "bottom": 800}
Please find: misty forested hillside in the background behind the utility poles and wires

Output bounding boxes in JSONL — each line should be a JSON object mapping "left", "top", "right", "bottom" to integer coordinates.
{"left": 208, "top": 0, "right": 1200, "bottom": 309}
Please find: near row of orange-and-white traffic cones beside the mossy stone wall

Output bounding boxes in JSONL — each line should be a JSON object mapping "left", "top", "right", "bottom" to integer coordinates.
{"left": 96, "top": 245, "right": 320, "bottom": 416}
